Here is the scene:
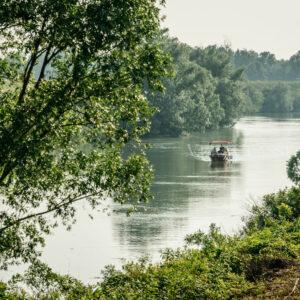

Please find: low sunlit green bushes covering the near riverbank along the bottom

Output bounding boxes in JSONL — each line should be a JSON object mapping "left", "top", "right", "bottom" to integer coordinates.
{"left": 0, "top": 156, "right": 300, "bottom": 300}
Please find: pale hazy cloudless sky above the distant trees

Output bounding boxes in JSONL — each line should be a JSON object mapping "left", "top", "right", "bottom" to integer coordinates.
{"left": 163, "top": 0, "right": 300, "bottom": 58}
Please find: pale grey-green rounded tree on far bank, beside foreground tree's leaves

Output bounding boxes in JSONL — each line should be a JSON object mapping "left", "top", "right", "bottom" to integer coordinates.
{"left": 149, "top": 35, "right": 223, "bottom": 136}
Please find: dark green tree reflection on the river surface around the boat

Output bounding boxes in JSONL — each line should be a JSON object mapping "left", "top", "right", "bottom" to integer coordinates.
{"left": 112, "top": 129, "right": 243, "bottom": 256}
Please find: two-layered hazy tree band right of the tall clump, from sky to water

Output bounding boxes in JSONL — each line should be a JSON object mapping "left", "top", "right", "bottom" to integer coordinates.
{"left": 232, "top": 50, "right": 300, "bottom": 114}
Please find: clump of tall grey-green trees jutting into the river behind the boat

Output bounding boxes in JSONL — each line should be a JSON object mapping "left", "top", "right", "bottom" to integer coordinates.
{"left": 145, "top": 36, "right": 246, "bottom": 136}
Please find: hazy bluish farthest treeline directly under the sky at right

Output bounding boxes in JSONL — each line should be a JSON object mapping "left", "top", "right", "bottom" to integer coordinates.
{"left": 231, "top": 50, "right": 300, "bottom": 81}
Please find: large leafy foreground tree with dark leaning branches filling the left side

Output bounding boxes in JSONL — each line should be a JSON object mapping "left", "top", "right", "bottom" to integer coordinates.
{"left": 0, "top": 0, "right": 168, "bottom": 268}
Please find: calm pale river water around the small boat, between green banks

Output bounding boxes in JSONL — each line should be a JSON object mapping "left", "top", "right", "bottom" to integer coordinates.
{"left": 3, "top": 116, "right": 300, "bottom": 282}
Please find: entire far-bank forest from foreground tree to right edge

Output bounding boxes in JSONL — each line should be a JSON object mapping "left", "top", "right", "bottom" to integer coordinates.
{"left": 144, "top": 33, "right": 300, "bottom": 136}
